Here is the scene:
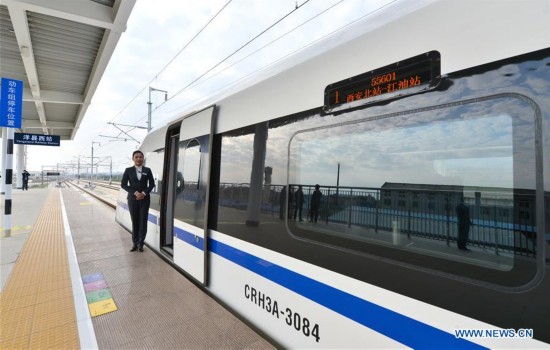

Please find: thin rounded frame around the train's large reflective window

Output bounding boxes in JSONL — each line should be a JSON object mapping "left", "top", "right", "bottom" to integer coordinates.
{"left": 285, "top": 93, "right": 545, "bottom": 292}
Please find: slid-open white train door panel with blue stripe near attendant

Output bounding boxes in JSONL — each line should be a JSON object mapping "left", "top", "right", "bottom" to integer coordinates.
{"left": 173, "top": 106, "right": 214, "bottom": 284}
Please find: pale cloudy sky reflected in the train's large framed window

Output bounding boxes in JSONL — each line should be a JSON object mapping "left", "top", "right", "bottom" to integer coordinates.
{"left": 291, "top": 116, "right": 513, "bottom": 188}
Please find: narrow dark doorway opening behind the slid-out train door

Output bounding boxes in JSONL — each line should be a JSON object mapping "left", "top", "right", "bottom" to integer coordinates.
{"left": 160, "top": 127, "right": 180, "bottom": 256}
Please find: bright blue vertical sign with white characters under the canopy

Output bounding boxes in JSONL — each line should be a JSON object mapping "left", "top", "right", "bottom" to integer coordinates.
{"left": 0, "top": 78, "right": 23, "bottom": 129}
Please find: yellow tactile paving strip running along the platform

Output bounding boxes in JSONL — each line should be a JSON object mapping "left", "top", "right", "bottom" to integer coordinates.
{"left": 0, "top": 189, "right": 80, "bottom": 350}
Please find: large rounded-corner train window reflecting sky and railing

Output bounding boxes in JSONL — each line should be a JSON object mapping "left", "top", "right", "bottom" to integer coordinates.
{"left": 288, "top": 96, "right": 537, "bottom": 286}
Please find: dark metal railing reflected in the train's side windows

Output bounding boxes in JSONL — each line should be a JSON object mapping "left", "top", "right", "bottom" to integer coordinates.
{"left": 219, "top": 183, "right": 536, "bottom": 256}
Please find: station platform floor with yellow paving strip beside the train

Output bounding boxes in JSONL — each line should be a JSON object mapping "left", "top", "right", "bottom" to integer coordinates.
{"left": 0, "top": 187, "right": 275, "bottom": 349}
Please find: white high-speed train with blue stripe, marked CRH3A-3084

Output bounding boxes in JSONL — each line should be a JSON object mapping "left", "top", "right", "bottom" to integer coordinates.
{"left": 116, "top": 0, "right": 550, "bottom": 349}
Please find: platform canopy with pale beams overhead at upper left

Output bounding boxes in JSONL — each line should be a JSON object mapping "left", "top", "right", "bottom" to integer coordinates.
{"left": 0, "top": 0, "right": 136, "bottom": 140}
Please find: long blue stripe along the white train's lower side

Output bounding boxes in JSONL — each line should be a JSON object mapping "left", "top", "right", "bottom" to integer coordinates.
{"left": 118, "top": 204, "right": 485, "bottom": 349}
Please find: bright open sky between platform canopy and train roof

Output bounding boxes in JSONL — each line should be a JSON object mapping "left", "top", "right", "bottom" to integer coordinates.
{"left": 8, "top": 0, "right": 394, "bottom": 174}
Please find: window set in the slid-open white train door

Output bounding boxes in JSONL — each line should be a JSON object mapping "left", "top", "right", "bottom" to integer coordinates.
{"left": 174, "top": 139, "right": 206, "bottom": 226}
